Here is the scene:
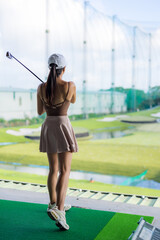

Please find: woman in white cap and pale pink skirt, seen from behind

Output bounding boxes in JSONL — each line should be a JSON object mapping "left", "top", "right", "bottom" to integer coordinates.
{"left": 37, "top": 54, "right": 78, "bottom": 230}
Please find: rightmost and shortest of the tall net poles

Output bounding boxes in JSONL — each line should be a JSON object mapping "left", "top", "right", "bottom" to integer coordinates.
{"left": 148, "top": 33, "right": 152, "bottom": 108}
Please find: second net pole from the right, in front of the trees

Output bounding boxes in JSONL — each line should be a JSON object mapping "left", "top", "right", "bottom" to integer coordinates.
{"left": 131, "top": 27, "right": 137, "bottom": 111}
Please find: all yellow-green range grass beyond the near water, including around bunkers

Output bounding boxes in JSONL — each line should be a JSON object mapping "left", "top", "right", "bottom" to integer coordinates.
{"left": 0, "top": 107, "right": 160, "bottom": 193}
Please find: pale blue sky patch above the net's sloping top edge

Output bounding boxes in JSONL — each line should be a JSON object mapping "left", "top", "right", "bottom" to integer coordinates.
{"left": 90, "top": 0, "right": 160, "bottom": 31}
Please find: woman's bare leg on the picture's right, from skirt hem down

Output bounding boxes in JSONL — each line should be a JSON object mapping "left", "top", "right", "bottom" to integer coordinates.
{"left": 56, "top": 152, "right": 72, "bottom": 210}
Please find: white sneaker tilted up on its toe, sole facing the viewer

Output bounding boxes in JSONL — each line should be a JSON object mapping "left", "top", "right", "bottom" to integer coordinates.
{"left": 47, "top": 208, "right": 69, "bottom": 230}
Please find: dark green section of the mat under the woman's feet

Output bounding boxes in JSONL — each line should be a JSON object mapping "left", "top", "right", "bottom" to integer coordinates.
{"left": 0, "top": 200, "right": 115, "bottom": 240}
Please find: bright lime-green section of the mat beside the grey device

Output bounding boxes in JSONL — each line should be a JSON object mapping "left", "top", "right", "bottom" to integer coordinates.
{"left": 95, "top": 213, "right": 153, "bottom": 240}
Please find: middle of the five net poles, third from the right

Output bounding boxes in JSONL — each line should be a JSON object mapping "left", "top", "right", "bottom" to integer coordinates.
{"left": 110, "top": 15, "right": 116, "bottom": 113}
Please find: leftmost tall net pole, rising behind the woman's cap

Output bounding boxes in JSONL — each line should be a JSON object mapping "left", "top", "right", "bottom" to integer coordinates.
{"left": 45, "top": 0, "right": 49, "bottom": 80}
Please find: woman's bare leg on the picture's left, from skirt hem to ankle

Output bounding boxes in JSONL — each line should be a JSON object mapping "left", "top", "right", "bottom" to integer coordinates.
{"left": 47, "top": 153, "right": 58, "bottom": 204}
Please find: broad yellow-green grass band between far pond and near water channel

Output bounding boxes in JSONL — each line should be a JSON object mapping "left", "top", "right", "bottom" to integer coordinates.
{"left": 0, "top": 132, "right": 160, "bottom": 181}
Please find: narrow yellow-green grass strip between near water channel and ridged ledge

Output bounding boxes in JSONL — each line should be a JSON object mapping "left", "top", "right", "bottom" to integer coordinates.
{"left": 0, "top": 169, "right": 160, "bottom": 197}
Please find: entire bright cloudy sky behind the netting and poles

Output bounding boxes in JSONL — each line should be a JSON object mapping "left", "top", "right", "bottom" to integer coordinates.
{"left": 0, "top": 0, "right": 160, "bottom": 90}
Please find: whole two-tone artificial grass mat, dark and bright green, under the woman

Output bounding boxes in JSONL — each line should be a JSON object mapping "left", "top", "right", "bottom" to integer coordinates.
{"left": 0, "top": 200, "right": 153, "bottom": 240}
